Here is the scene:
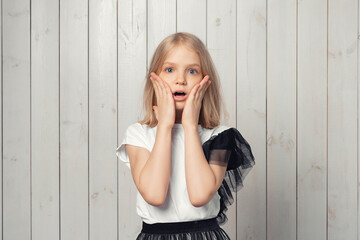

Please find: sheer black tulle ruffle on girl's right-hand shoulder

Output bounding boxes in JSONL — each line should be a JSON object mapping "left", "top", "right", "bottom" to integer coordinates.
{"left": 202, "top": 128, "right": 255, "bottom": 225}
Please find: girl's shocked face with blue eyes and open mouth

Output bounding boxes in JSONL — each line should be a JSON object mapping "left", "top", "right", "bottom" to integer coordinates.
{"left": 159, "top": 45, "right": 203, "bottom": 110}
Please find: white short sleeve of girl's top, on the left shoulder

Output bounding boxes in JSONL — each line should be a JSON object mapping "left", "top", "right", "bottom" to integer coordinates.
{"left": 116, "top": 123, "right": 151, "bottom": 169}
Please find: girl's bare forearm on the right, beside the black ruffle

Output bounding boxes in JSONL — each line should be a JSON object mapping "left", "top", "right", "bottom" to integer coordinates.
{"left": 185, "top": 127, "right": 216, "bottom": 206}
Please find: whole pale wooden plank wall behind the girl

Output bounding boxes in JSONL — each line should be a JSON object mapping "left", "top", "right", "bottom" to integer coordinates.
{"left": 0, "top": 0, "right": 360, "bottom": 240}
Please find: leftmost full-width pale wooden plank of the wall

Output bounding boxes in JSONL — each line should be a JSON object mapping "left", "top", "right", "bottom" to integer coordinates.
{"left": 3, "top": 0, "right": 31, "bottom": 240}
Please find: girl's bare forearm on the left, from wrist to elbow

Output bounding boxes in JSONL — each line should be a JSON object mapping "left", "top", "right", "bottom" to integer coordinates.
{"left": 139, "top": 126, "right": 171, "bottom": 204}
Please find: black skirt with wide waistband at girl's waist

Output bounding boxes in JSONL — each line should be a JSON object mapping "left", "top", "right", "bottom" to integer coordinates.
{"left": 136, "top": 218, "right": 230, "bottom": 240}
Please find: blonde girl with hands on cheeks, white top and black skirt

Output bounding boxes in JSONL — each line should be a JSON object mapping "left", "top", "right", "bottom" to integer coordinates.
{"left": 116, "top": 32, "right": 255, "bottom": 240}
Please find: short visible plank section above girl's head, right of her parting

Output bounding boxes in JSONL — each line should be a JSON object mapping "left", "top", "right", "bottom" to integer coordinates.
{"left": 176, "top": 0, "right": 206, "bottom": 45}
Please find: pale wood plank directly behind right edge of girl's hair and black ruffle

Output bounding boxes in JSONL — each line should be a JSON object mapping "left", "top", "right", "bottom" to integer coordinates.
{"left": 207, "top": 0, "right": 236, "bottom": 239}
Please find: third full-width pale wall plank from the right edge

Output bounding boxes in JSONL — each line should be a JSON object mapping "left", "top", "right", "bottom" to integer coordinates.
{"left": 266, "top": 0, "right": 297, "bottom": 240}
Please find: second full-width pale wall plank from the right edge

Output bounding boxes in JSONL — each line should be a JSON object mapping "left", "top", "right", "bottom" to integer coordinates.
{"left": 297, "top": 0, "right": 327, "bottom": 240}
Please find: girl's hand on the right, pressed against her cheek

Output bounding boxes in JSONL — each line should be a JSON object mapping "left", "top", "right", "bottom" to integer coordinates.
{"left": 181, "top": 75, "right": 211, "bottom": 127}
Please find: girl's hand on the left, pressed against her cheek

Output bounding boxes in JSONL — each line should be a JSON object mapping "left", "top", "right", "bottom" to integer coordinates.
{"left": 150, "top": 72, "right": 175, "bottom": 128}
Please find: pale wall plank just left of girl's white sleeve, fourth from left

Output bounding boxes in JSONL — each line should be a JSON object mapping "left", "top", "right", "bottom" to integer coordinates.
{"left": 88, "top": 0, "right": 118, "bottom": 239}
